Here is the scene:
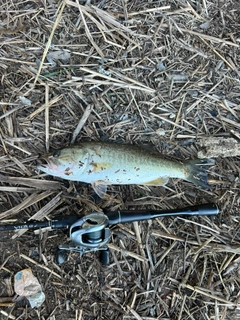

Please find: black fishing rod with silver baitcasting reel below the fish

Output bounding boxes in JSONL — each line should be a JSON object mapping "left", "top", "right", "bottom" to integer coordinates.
{"left": 0, "top": 203, "right": 219, "bottom": 265}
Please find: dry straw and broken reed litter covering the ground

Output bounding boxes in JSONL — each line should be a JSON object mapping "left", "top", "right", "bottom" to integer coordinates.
{"left": 0, "top": 0, "right": 240, "bottom": 320}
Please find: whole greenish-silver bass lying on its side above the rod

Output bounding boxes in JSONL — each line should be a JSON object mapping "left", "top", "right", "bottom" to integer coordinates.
{"left": 38, "top": 141, "right": 212, "bottom": 198}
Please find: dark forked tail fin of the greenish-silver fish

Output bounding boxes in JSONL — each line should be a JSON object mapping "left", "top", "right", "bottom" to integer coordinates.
{"left": 185, "top": 159, "right": 215, "bottom": 189}
